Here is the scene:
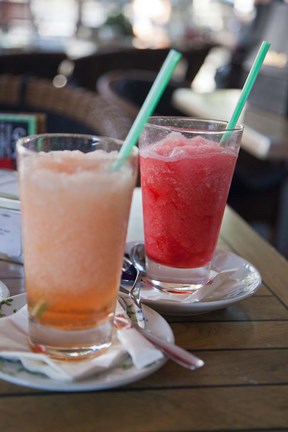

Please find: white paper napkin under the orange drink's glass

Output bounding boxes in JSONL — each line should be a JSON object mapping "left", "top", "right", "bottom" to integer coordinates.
{"left": 0, "top": 303, "right": 163, "bottom": 381}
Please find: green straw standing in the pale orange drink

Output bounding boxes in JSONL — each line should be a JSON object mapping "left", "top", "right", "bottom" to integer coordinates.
{"left": 113, "top": 49, "right": 182, "bottom": 170}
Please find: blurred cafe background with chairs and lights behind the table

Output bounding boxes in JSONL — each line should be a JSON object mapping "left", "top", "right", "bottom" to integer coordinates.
{"left": 0, "top": 0, "right": 288, "bottom": 256}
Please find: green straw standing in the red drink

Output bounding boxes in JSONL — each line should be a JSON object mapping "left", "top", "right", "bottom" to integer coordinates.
{"left": 225, "top": 41, "right": 270, "bottom": 138}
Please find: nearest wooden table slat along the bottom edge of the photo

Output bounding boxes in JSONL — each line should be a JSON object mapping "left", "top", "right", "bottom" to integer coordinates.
{"left": 0, "top": 386, "right": 288, "bottom": 432}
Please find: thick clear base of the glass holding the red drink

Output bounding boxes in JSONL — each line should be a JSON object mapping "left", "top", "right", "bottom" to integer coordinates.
{"left": 146, "top": 257, "right": 211, "bottom": 294}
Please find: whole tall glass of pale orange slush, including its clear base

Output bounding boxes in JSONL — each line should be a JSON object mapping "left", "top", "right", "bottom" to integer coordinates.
{"left": 17, "top": 134, "right": 138, "bottom": 359}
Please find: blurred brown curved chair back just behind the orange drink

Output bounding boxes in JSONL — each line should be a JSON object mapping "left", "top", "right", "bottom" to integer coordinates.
{"left": 0, "top": 74, "right": 130, "bottom": 138}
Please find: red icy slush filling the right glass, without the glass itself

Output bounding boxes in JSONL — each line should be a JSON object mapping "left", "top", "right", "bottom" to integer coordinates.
{"left": 140, "top": 132, "right": 237, "bottom": 269}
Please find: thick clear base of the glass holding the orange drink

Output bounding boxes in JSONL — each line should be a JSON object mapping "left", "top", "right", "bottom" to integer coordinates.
{"left": 29, "top": 318, "right": 112, "bottom": 360}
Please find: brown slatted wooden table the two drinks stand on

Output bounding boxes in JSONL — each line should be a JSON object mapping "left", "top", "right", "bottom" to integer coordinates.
{"left": 0, "top": 190, "right": 288, "bottom": 432}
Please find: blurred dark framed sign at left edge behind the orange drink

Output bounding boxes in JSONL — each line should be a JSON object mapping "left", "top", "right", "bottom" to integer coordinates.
{"left": 0, "top": 113, "right": 45, "bottom": 169}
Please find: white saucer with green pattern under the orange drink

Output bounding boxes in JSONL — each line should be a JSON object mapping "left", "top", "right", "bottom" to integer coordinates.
{"left": 0, "top": 294, "right": 174, "bottom": 392}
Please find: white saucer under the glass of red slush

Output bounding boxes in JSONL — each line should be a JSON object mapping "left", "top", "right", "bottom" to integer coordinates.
{"left": 126, "top": 243, "right": 262, "bottom": 316}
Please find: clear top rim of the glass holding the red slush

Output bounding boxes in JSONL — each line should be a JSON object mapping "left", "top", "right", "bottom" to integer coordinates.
{"left": 145, "top": 116, "right": 244, "bottom": 135}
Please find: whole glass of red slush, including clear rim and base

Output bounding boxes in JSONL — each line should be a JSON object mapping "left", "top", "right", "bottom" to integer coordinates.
{"left": 139, "top": 117, "right": 243, "bottom": 292}
